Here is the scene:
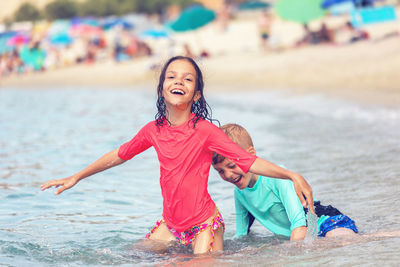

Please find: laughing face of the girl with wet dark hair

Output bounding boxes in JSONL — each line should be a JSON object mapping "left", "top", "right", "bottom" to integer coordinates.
{"left": 162, "top": 59, "right": 201, "bottom": 111}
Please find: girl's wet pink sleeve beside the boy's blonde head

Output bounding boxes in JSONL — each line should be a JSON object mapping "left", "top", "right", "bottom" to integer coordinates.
{"left": 207, "top": 123, "right": 257, "bottom": 173}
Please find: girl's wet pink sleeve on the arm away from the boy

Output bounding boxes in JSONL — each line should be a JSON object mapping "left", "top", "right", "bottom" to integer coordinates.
{"left": 118, "top": 124, "right": 152, "bottom": 160}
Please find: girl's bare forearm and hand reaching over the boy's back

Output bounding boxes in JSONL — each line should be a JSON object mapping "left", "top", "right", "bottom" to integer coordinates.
{"left": 249, "top": 158, "right": 315, "bottom": 214}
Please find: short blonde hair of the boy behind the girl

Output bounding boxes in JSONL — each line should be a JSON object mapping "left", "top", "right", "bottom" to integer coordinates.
{"left": 212, "top": 123, "right": 254, "bottom": 164}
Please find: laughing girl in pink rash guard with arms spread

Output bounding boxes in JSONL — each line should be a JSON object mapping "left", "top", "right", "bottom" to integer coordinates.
{"left": 41, "top": 56, "right": 313, "bottom": 254}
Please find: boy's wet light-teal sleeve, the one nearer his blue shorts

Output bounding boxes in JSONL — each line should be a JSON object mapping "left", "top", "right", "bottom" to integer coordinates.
{"left": 274, "top": 179, "right": 307, "bottom": 231}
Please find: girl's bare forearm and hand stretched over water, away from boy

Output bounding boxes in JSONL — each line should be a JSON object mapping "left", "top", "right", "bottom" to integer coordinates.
{"left": 40, "top": 149, "right": 125, "bottom": 195}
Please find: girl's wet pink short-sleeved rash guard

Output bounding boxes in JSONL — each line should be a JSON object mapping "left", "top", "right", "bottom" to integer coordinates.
{"left": 118, "top": 114, "right": 257, "bottom": 232}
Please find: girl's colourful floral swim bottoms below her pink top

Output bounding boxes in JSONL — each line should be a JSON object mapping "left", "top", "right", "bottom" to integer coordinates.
{"left": 146, "top": 211, "right": 225, "bottom": 251}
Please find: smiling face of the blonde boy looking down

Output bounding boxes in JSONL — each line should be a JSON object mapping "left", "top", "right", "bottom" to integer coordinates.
{"left": 213, "top": 158, "right": 252, "bottom": 189}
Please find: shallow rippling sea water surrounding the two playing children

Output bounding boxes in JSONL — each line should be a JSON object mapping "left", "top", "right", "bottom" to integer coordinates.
{"left": 0, "top": 88, "right": 400, "bottom": 266}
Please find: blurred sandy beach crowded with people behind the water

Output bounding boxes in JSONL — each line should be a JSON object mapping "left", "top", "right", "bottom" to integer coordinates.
{"left": 0, "top": 0, "right": 400, "bottom": 105}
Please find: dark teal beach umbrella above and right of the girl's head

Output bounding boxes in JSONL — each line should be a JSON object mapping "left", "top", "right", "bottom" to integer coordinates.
{"left": 167, "top": 6, "right": 215, "bottom": 32}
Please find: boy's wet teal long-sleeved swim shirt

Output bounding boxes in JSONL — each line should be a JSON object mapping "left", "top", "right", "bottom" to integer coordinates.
{"left": 234, "top": 176, "right": 307, "bottom": 237}
